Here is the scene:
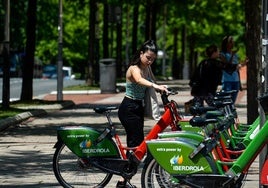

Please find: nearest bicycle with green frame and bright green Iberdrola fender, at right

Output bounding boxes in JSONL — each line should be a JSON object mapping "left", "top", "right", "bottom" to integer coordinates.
{"left": 142, "top": 94, "right": 268, "bottom": 188}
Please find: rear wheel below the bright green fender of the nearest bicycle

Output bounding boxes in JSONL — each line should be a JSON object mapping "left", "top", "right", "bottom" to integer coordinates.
{"left": 141, "top": 156, "right": 190, "bottom": 188}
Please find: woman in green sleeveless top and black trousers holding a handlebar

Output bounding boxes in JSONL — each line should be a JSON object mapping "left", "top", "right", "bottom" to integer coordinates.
{"left": 116, "top": 40, "right": 168, "bottom": 187}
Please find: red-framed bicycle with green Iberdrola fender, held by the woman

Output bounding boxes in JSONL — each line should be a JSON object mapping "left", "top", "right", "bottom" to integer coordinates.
{"left": 53, "top": 91, "right": 181, "bottom": 187}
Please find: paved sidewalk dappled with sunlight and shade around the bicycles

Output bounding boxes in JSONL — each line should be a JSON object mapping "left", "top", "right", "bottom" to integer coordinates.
{"left": 0, "top": 79, "right": 259, "bottom": 188}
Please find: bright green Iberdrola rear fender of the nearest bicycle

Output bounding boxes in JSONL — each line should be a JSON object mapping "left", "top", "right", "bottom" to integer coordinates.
{"left": 146, "top": 138, "right": 213, "bottom": 175}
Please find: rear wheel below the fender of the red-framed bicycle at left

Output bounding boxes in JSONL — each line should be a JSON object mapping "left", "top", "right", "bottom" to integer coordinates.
{"left": 53, "top": 143, "right": 113, "bottom": 188}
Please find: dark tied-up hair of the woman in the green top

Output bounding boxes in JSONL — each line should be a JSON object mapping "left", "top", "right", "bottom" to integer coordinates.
{"left": 129, "top": 40, "right": 158, "bottom": 66}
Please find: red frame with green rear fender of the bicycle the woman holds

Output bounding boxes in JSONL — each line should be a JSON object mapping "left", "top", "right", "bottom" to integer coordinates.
{"left": 54, "top": 92, "right": 181, "bottom": 179}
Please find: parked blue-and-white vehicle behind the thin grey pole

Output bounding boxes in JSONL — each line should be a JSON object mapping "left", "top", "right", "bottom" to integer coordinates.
{"left": 42, "top": 65, "right": 75, "bottom": 80}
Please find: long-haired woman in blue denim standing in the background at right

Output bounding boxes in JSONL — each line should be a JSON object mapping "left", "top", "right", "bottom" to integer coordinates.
{"left": 220, "top": 36, "right": 248, "bottom": 103}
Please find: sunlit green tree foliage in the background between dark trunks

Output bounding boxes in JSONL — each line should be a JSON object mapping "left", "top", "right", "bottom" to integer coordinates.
{"left": 4, "top": 0, "right": 245, "bottom": 77}
